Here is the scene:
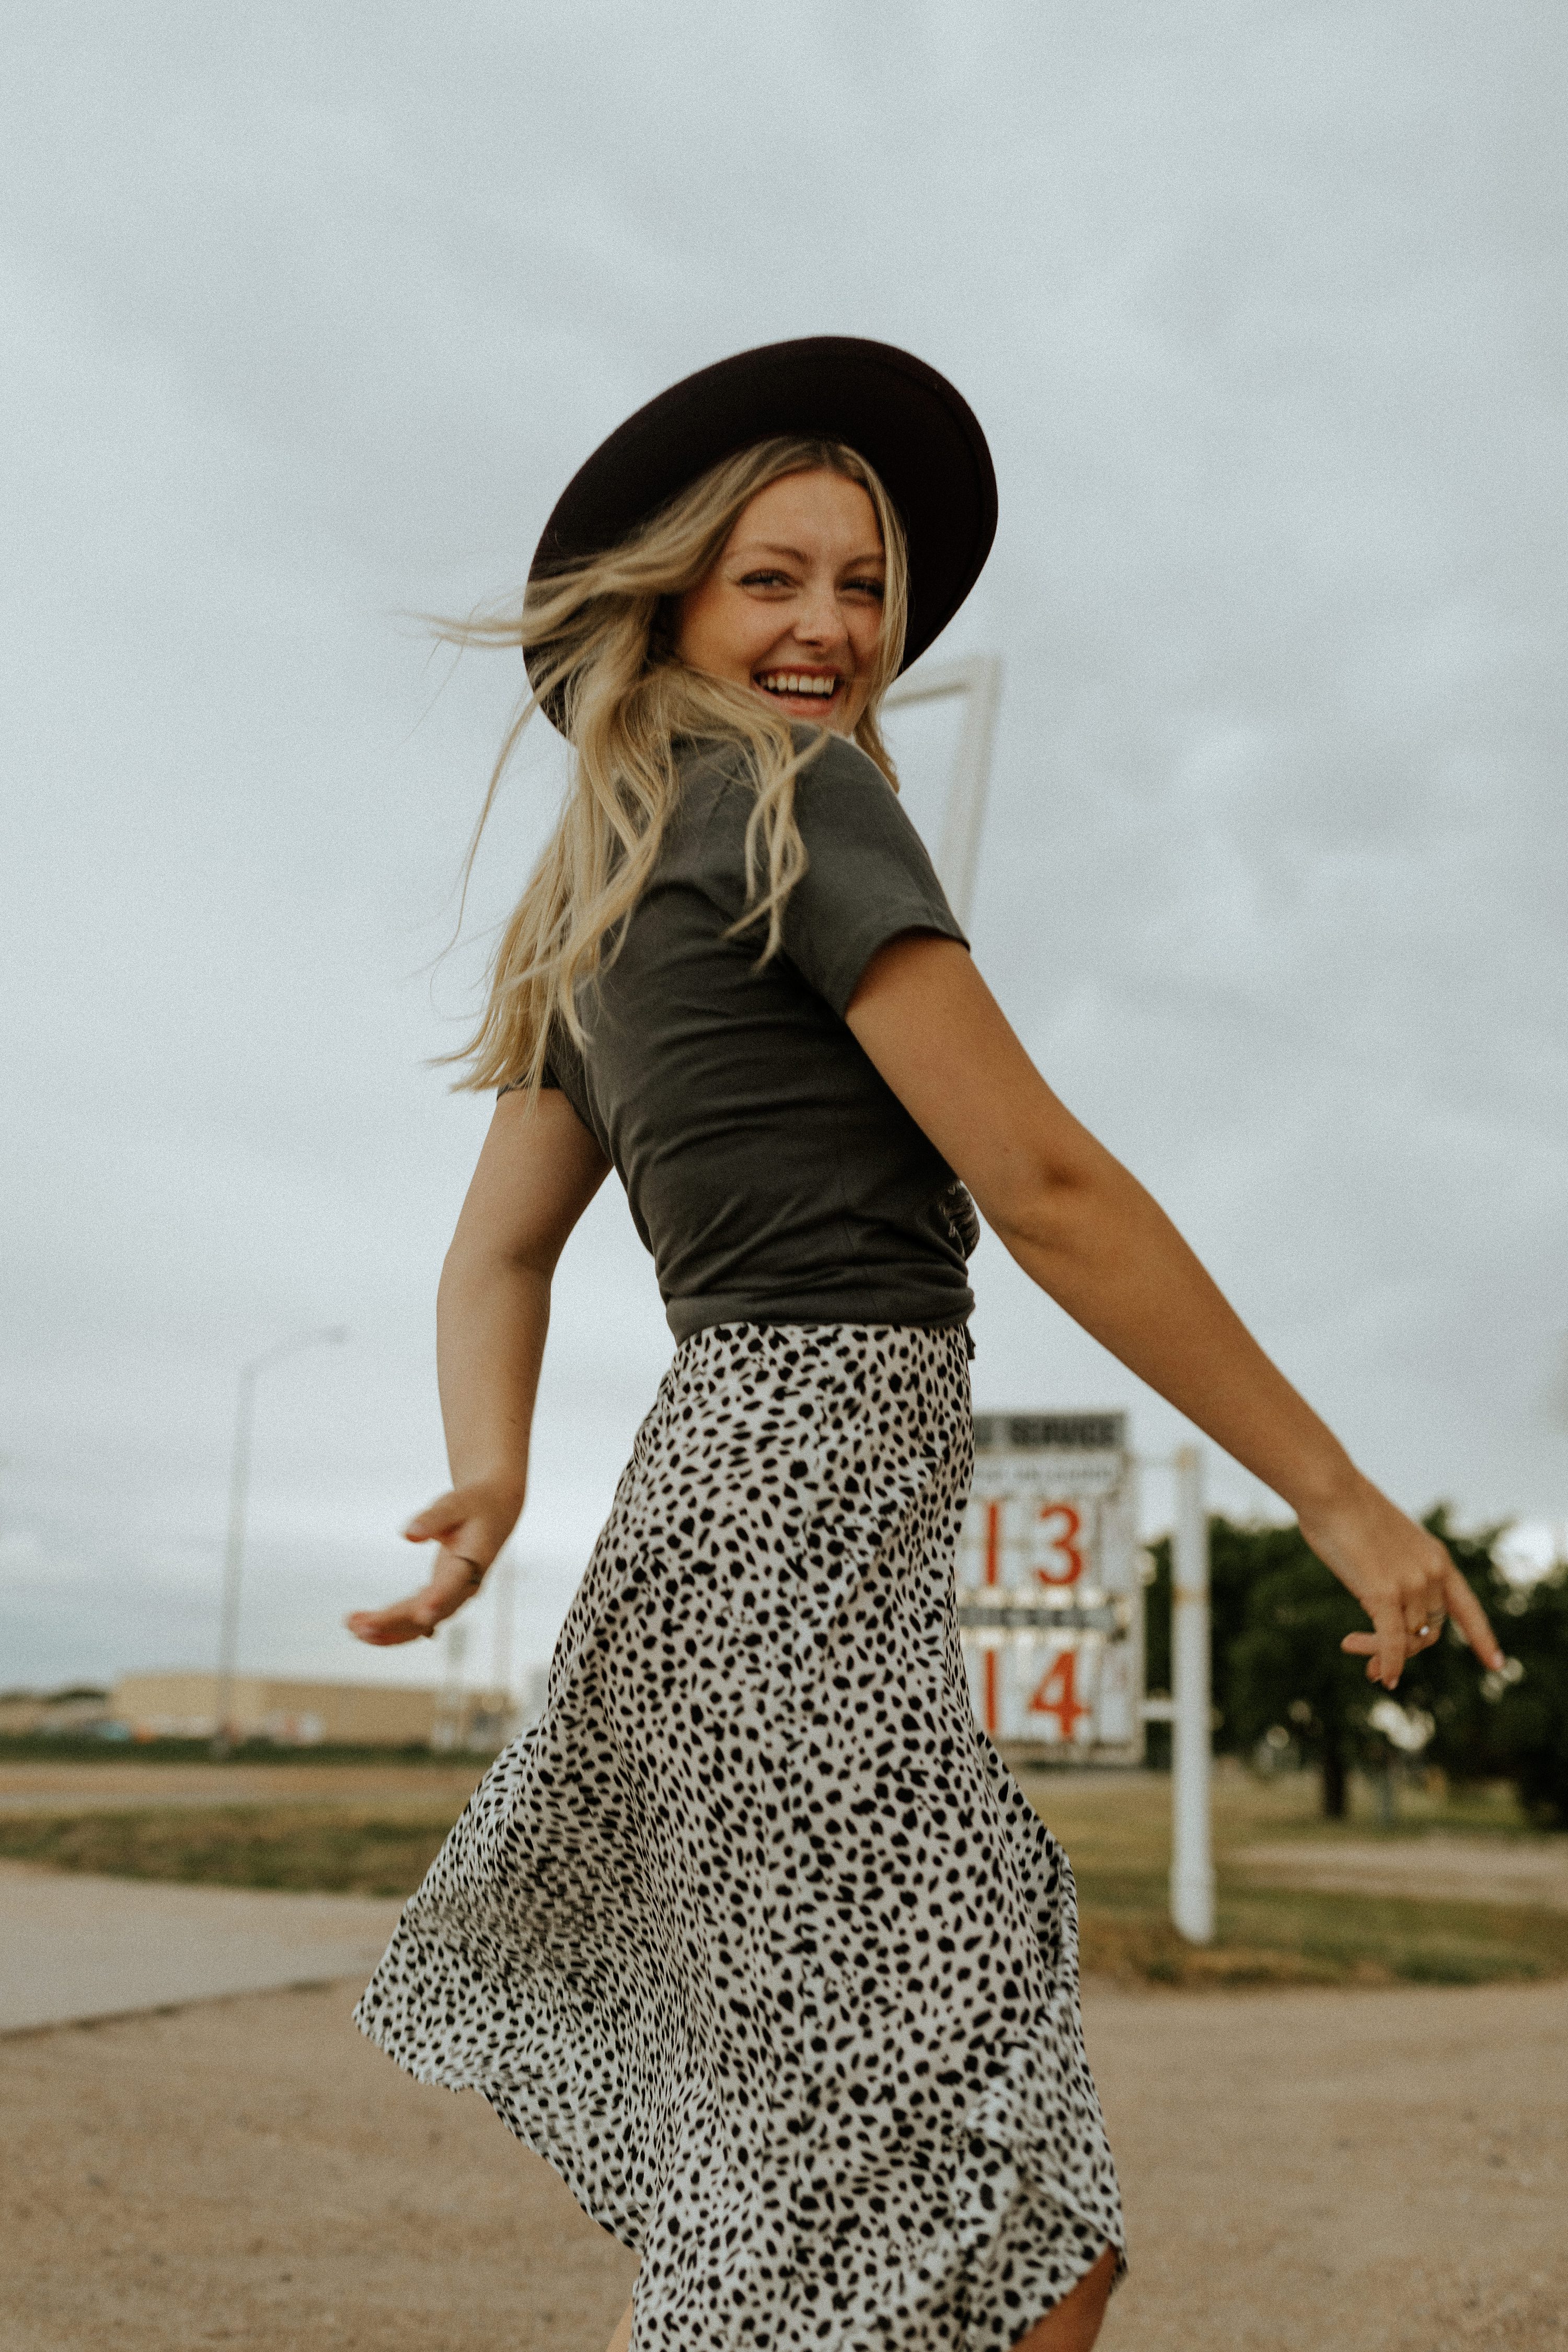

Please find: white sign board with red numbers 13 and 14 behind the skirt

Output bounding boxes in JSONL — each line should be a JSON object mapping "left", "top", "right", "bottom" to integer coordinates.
{"left": 957, "top": 1414, "right": 1143, "bottom": 1764}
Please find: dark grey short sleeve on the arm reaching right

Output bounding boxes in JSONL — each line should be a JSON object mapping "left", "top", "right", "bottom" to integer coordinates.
{"left": 783, "top": 736, "right": 969, "bottom": 1019}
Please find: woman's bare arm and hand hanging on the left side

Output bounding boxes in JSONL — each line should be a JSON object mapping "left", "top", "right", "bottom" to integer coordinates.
{"left": 348, "top": 1089, "right": 609, "bottom": 1646}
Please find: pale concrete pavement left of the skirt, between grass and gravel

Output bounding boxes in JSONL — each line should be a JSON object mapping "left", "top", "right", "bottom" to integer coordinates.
{"left": 0, "top": 1863, "right": 402, "bottom": 2032}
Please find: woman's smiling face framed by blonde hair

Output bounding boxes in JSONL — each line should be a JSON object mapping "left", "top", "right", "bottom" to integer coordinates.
{"left": 675, "top": 473, "right": 886, "bottom": 734}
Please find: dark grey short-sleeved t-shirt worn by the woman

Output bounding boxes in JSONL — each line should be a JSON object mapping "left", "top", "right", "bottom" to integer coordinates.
{"left": 545, "top": 736, "right": 978, "bottom": 1339}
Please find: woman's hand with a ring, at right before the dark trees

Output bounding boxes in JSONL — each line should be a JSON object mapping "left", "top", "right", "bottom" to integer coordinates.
{"left": 1300, "top": 1480, "right": 1502, "bottom": 1691}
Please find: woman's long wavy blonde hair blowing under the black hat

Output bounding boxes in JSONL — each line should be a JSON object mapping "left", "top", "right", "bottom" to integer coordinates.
{"left": 435, "top": 435, "right": 907, "bottom": 1091}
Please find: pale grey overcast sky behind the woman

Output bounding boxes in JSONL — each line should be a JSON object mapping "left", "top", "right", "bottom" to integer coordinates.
{"left": 0, "top": 0, "right": 1568, "bottom": 1684}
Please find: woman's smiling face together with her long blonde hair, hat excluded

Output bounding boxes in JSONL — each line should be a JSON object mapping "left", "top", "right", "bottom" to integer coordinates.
{"left": 416, "top": 433, "right": 907, "bottom": 1089}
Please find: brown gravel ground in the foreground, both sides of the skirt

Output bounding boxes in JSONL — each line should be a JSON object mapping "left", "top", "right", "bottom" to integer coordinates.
{"left": 0, "top": 1985, "right": 1568, "bottom": 2352}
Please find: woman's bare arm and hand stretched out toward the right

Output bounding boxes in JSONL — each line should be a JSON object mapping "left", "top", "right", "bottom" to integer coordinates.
{"left": 849, "top": 936, "right": 1500, "bottom": 1689}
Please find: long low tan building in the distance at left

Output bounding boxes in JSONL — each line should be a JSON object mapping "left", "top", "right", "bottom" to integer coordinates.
{"left": 103, "top": 1670, "right": 526, "bottom": 1750}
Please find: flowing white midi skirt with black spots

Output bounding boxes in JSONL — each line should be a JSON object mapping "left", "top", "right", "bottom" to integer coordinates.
{"left": 358, "top": 1324, "right": 1121, "bottom": 2352}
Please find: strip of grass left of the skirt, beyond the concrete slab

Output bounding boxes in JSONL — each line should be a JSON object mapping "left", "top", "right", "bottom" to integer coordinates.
{"left": 0, "top": 1804, "right": 452, "bottom": 1896}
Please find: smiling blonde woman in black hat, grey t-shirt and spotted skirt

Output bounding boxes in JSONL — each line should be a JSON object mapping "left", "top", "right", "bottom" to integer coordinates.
{"left": 348, "top": 339, "right": 1495, "bottom": 2352}
